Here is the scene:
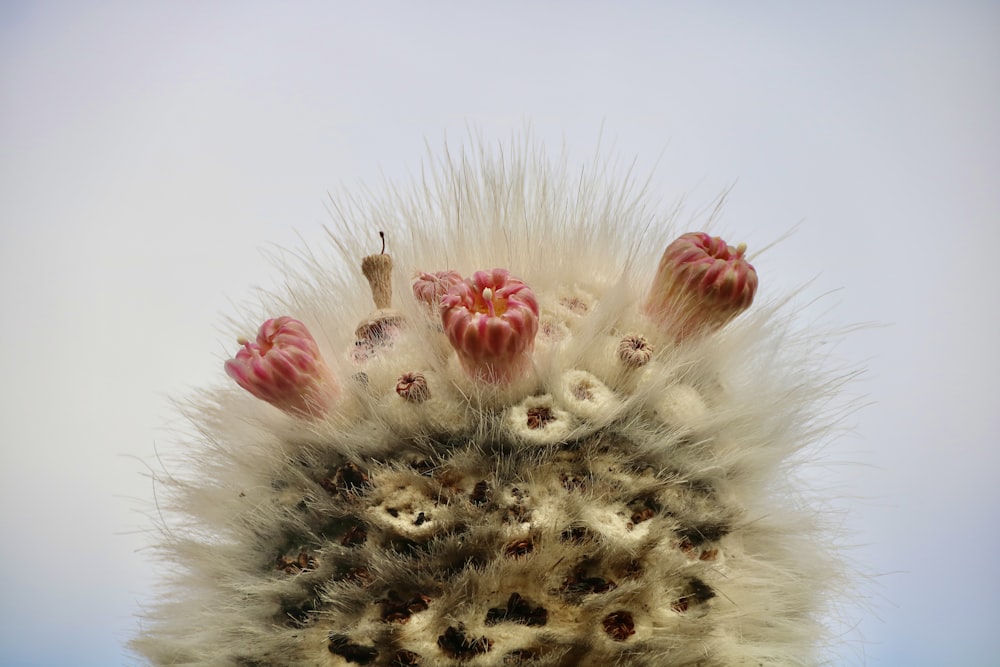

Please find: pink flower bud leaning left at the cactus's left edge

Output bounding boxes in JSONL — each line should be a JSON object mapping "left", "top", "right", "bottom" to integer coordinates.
{"left": 226, "top": 317, "right": 337, "bottom": 417}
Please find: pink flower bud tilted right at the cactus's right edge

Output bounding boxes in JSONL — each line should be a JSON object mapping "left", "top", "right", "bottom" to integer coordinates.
{"left": 645, "top": 232, "right": 757, "bottom": 341}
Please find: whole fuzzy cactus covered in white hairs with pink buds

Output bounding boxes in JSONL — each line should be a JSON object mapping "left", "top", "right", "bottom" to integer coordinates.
{"left": 132, "top": 141, "right": 852, "bottom": 667}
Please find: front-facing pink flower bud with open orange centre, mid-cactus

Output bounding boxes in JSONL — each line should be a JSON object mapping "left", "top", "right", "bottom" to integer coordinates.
{"left": 441, "top": 269, "right": 538, "bottom": 384}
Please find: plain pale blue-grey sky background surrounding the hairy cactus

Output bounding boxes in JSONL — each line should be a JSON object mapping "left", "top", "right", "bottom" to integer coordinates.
{"left": 0, "top": 0, "right": 1000, "bottom": 667}
